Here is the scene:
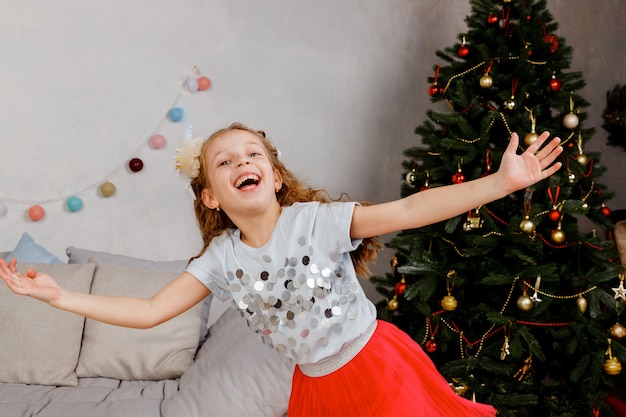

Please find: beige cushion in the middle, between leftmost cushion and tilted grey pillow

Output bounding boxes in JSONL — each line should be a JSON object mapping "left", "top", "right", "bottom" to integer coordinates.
{"left": 76, "top": 262, "right": 202, "bottom": 380}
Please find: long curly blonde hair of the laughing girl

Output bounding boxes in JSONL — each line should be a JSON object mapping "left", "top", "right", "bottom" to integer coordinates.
{"left": 190, "top": 123, "right": 382, "bottom": 277}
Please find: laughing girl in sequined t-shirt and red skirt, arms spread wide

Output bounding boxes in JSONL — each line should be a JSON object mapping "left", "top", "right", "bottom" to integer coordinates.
{"left": 0, "top": 124, "right": 562, "bottom": 417}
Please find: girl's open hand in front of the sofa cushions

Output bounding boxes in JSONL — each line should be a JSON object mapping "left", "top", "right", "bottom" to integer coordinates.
{"left": 0, "top": 259, "right": 62, "bottom": 303}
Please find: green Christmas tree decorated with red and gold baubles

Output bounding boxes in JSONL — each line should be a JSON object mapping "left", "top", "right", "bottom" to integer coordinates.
{"left": 373, "top": 0, "right": 626, "bottom": 417}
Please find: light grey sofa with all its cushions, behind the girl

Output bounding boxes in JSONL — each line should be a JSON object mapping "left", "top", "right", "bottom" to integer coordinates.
{"left": 0, "top": 233, "right": 294, "bottom": 417}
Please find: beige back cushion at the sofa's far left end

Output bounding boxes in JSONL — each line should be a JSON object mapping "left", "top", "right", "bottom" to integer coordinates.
{"left": 0, "top": 264, "right": 94, "bottom": 386}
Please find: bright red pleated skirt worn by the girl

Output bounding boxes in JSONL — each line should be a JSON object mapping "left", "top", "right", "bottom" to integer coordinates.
{"left": 288, "top": 320, "right": 496, "bottom": 417}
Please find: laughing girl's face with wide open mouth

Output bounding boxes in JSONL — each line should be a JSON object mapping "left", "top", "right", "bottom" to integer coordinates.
{"left": 202, "top": 129, "right": 282, "bottom": 216}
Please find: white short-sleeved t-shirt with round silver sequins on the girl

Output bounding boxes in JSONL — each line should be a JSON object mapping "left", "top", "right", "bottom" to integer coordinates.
{"left": 187, "top": 202, "right": 376, "bottom": 364}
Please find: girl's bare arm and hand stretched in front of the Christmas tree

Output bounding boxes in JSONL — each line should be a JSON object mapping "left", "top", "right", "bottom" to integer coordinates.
{"left": 350, "top": 132, "right": 563, "bottom": 239}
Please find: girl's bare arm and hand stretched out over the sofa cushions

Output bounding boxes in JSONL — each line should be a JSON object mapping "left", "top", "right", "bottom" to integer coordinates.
{"left": 0, "top": 259, "right": 211, "bottom": 328}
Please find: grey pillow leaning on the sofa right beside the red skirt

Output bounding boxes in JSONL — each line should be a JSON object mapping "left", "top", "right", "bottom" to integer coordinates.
{"left": 161, "top": 308, "right": 294, "bottom": 417}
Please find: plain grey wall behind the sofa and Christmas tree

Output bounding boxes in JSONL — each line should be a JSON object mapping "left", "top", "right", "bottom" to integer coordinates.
{"left": 0, "top": 0, "right": 626, "bottom": 300}
